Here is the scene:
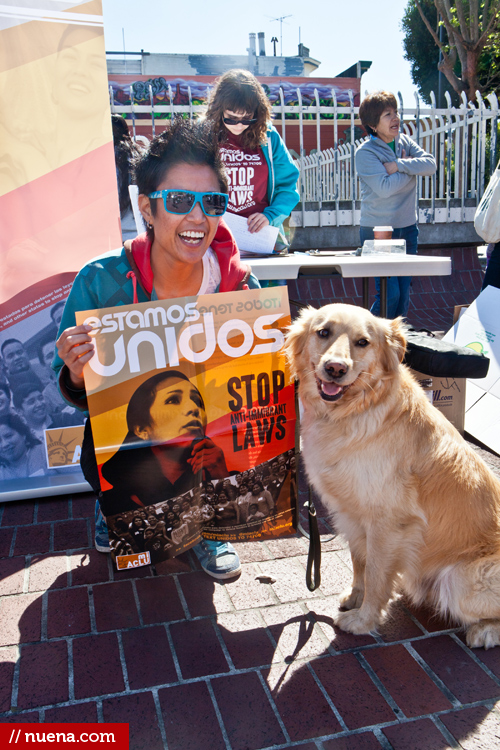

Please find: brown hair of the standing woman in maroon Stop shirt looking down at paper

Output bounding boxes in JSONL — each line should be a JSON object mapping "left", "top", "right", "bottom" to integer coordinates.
{"left": 207, "top": 70, "right": 271, "bottom": 148}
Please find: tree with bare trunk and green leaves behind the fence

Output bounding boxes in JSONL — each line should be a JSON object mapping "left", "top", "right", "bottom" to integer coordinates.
{"left": 402, "top": 0, "right": 500, "bottom": 101}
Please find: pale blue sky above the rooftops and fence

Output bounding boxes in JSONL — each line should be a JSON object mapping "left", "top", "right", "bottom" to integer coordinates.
{"left": 102, "top": 0, "right": 426, "bottom": 107}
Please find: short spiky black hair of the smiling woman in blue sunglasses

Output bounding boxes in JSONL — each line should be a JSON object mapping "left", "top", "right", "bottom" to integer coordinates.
{"left": 135, "top": 117, "right": 228, "bottom": 240}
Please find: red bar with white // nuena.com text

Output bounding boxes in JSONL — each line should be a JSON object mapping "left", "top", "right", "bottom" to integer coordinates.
{"left": 0, "top": 719, "right": 129, "bottom": 750}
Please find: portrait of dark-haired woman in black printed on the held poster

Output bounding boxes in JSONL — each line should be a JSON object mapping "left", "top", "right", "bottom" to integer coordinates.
{"left": 101, "top": 370, "right": 229, "bottom": 516}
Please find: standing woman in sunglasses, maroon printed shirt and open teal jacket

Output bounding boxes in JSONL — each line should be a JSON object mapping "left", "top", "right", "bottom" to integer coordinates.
{"left": 207, "top": 70, "right": 299, "bottom": 250}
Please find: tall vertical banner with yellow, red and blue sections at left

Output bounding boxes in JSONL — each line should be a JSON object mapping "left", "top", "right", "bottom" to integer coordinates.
{"left": 0, "top": 0, "right": 121, "bottom": 501}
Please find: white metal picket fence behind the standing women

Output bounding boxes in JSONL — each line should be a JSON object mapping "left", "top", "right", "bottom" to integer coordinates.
{"left": 110, "top": 86, "right": 500, "bottom": 226}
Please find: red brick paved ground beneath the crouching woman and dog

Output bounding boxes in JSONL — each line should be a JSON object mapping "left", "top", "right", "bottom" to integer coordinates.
{"left": 0, "top": 438, "right": 500, "bottom": 750}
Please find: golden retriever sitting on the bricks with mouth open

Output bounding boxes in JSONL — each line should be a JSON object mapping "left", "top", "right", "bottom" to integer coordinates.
{"left": 286, "top": 304, "right": 500, "bottom": 648}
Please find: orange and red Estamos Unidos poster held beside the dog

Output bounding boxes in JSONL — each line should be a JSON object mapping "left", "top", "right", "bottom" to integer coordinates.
{"left": 77, "top": 287, "right": 297, "bottom": 567}
